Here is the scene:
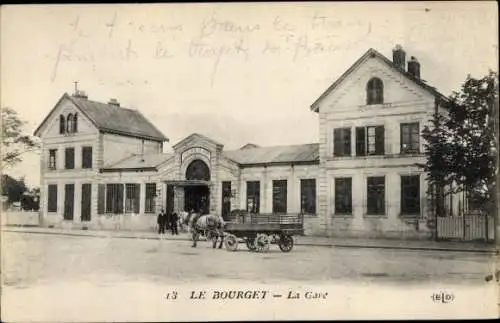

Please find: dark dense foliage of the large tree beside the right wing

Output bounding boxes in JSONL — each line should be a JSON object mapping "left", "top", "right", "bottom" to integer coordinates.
{"left": 422, "top": 71, "right": 498, "bottom": 215}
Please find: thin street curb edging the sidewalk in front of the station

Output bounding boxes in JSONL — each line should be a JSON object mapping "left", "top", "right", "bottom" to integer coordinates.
{"left": 2, "top": 229, "right": 499, "bottom": 255}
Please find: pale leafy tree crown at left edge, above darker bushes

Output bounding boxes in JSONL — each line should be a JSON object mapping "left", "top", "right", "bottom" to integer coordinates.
{"left": 1, "top": 107, "right": 40, "bottom": 166}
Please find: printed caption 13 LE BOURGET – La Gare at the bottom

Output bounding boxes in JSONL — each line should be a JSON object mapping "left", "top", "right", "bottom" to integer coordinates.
{"left": 165, "top": 290, "right": 328, "bottom": 300}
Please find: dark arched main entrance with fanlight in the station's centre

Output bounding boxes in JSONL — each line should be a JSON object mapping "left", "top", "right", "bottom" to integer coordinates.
{"left": 184, "top": 159, "right": 210, "bottom": 214}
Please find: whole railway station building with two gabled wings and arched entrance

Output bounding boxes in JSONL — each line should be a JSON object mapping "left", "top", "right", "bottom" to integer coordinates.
{"left": 35, "top": 46, "right": 446, "bottom": 237}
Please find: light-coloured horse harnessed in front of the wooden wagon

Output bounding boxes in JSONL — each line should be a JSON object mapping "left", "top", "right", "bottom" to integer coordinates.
{"left": 179, "top": 212, "right": 225, "bottom": 249}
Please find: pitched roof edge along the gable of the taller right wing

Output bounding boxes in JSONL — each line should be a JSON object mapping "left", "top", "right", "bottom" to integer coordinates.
{"left": 311, "top": 48, "right": 448, "bottom": 112}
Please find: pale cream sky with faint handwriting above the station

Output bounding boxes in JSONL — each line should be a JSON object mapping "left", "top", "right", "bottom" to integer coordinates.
{"left": 0, "top": 1, "right": 498, "bottom": 186}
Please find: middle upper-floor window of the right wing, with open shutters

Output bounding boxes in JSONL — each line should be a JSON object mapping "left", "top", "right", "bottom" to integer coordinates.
{"left": 356, "top": 126, "right": 385, "bottom": 156}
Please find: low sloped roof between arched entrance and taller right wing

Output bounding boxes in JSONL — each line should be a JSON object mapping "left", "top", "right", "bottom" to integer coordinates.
{"left": 222, "top": 144, "right": 319, "bottom": 165}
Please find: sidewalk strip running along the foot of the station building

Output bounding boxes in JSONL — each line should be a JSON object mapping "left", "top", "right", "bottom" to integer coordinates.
{"left": 2, "top": 226, "right": 498, "bottom": 254}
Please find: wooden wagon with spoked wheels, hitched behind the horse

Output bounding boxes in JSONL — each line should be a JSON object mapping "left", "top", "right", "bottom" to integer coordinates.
{"left": 224, "top": 213, "right": 304, "bottom": 252}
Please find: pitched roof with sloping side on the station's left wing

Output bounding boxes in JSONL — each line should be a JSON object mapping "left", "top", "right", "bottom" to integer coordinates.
{"left": 35, "top": 93, "right": 168, "bottom": 141}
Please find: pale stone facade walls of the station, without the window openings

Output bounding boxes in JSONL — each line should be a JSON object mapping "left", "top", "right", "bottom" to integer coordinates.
{"left": 38, "top": 49, "right": 456, "bottom": 238}
